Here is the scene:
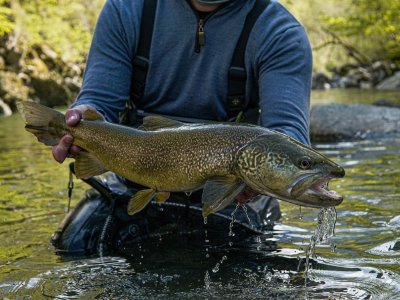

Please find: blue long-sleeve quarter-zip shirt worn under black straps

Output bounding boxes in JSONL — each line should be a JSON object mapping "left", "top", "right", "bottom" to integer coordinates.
{"left": 73, "top": 0, "right": 312, "bottom": 144}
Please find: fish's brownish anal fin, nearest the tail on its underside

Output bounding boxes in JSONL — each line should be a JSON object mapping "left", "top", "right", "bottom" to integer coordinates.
{"left": 75, "top": 151, "right": 108, "bottom": 179}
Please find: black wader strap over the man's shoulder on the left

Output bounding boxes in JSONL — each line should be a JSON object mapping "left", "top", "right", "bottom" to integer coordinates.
{"left": 120, "top": 0, "right": 157, "bottom": 125}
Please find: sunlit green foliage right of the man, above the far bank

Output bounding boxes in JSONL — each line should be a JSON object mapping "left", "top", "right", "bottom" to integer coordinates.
{"left": 280, "top": 0, "right": 400, "bottom": 71}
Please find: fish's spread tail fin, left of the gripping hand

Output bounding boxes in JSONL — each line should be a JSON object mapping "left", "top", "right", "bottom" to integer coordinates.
{"left": 17, "top": 101, "right": 64, "bottom": 146}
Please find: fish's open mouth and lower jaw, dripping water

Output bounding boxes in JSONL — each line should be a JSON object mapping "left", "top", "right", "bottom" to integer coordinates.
{"left": 289, "top": 173, "right": 344, "bottom": 207}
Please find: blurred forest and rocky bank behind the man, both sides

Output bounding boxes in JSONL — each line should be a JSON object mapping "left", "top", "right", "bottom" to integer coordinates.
{"left": 0, "top": 0, "right": 400, "bottom": 109}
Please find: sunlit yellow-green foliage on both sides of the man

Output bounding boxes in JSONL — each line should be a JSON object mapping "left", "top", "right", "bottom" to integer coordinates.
{"left": 0, "top": 0, "right": 400, "bottom": 70}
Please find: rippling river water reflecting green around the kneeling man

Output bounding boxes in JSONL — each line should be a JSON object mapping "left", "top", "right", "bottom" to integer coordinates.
{"left": 0, "top": 91, "right": 400, "bottom": 299}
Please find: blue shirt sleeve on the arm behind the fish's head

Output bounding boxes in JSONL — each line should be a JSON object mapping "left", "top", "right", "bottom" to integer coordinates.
{"left": 258, "top": 25, "right": 312, "bottom": 145}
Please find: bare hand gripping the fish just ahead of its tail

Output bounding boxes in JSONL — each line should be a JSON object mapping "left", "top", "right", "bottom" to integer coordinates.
{"left": 52, "top": 104, "right": 96, "bottom": 163}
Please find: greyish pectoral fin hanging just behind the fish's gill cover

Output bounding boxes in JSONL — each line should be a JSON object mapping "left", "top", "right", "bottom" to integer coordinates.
{"left": 201, "top": 177, "right": 246, "bottom": 217}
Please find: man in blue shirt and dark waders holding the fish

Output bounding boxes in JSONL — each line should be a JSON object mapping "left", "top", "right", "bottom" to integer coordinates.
{"left": 52, "top": 0, "right": 312, "bottom": 254}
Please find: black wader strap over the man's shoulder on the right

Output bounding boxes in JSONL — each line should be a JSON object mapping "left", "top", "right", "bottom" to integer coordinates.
{"left": 225, "top": 0, "right": 270, "bottom": 119}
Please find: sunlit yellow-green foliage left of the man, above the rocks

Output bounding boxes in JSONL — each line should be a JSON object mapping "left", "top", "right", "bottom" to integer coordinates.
{"left": 12, "top": 0, "right": 104, "bottom": 62}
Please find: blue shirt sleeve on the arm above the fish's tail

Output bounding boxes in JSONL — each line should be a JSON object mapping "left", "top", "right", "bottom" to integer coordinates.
{"left": 71, "top": 0, "right": 141, "bottom": 122}
